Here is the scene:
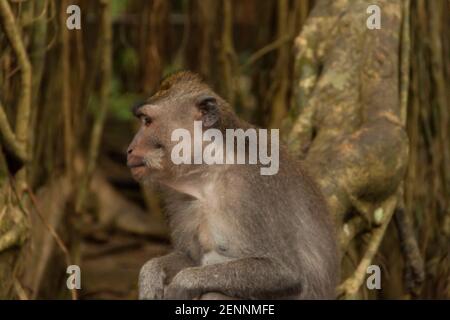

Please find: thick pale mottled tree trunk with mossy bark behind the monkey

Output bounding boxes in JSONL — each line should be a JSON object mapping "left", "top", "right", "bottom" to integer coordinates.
{"left": 287, "top": 0, "right": 422, "bottom": 297}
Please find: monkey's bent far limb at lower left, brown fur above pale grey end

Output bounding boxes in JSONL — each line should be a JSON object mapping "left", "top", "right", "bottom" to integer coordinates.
{"left": 139, "top": 251, "right": 194, "bottom": 299}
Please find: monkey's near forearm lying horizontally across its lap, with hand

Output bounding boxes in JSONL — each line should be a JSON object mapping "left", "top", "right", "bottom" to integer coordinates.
{"left": 164, "top": 258, "right": 301, "bottom": 299}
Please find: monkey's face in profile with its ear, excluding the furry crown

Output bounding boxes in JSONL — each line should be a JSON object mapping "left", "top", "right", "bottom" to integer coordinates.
{"left": 127, "top": 75, "right": 218, "bottom": 183}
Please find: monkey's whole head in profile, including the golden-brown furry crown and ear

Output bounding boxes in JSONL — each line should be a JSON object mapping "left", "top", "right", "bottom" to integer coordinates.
{"left": 127, "top": 71, "right": 235, "bottom": 182}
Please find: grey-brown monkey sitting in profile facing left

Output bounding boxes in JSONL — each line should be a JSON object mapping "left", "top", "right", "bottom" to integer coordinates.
{"left": 127, "top": 71, "right": 339, "bottom": 299}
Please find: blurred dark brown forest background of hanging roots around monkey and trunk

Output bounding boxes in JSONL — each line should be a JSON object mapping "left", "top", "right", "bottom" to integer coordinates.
{"left": 0, "top": 0, "right": 450, "bottom": 299}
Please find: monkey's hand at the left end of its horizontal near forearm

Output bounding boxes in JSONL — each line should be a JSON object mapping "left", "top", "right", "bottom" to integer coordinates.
{"left": 164, "top": 268, "right": 202, "bottom": 300}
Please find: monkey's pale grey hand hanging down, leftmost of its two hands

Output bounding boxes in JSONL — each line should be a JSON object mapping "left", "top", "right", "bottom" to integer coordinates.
{"left": 139, "top": 258, "right": 166, "bottom": 300}
